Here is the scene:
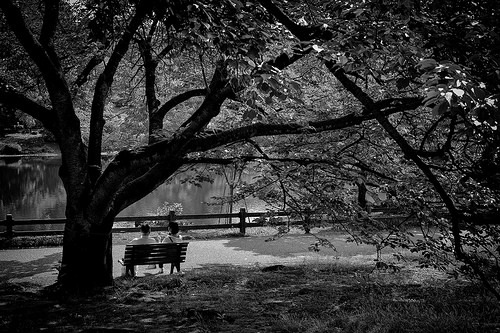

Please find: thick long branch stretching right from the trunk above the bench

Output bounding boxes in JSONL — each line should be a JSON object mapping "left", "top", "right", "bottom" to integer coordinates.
{"left": 89, "top": 93, "right": 412, "bottom": 222}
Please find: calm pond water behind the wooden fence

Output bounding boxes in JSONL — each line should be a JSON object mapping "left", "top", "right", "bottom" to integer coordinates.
{"left": 0, "top": 157, "right": 265, "bottom": 229}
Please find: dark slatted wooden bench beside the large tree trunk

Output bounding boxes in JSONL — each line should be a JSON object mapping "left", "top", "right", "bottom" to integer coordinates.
{"left": 119, "top": 242, "right": 189, "bottom": 276}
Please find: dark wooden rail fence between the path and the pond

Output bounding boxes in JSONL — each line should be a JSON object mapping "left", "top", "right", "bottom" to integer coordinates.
{"left": 0, "top": 208, "right": 289, "bottom": 238}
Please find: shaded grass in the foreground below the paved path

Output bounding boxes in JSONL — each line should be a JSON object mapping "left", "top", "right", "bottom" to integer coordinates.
{"left": 0, "top": 262, "right": 500, "bottom": 333}
